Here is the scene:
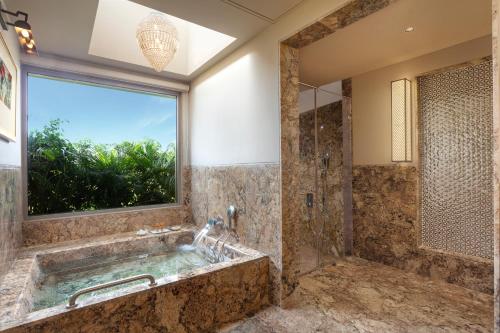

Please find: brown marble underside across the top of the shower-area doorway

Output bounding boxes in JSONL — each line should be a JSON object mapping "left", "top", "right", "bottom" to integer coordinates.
{"left": 284, "top": 0, "right": 397, "bottom": 48}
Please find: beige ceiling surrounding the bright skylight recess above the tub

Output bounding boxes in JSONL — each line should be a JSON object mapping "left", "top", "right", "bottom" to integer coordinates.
{"left": 5, "top": 0, "right": 302, "bottom": 81}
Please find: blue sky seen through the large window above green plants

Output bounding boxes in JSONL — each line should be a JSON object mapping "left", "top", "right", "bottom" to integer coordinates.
{"left": 28, "top": 76, "right": 176, "bottom": 147}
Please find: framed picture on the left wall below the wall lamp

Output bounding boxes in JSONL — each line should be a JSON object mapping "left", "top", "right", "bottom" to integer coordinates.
{"left": 0, "top": 33, "right": 17, "bottom": 141}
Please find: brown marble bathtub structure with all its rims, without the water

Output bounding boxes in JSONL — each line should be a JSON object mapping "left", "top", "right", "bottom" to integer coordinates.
{"left": 0, "top": 226, "right": 269, "bottom": 333}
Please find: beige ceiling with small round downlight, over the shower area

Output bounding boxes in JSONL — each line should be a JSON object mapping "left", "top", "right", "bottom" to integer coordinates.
{"left": 300, "top": 0, "right": 491, "bottom": 86}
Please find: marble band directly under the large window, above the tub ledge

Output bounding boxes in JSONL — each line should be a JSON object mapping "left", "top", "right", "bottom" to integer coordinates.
{"left": 22, "top": 168, "right": 191, "bottom": 246}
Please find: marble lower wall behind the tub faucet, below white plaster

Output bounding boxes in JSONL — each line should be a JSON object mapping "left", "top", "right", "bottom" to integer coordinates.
{"left": 191, "top": 164, "right": 281, "bottom": 302}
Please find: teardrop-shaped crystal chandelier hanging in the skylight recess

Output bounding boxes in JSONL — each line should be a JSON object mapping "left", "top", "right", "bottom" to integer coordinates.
{"left": 136, "top": 13, "right": 179, "bottom": 72}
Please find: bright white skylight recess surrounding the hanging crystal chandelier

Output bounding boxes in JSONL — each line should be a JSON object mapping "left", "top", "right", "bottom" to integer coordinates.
{"left": 89, "top": 0, "right": 235, "bottom": 76}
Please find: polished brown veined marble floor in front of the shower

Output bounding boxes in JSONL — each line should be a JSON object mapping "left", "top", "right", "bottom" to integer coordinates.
{"left": 221, "top": 258, "right": 493, "bottom": 333}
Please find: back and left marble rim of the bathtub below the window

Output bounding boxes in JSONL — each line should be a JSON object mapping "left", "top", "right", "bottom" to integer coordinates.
{"left": 0, "top": 225, "right": 194, "bottom": 323}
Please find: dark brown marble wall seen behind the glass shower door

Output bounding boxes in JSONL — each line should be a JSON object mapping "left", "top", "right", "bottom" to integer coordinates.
{"left": 299, "top": 101, "right": 344, "bottom": 255}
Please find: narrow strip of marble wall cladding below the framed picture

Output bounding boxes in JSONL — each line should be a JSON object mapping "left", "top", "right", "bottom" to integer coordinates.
{"left": 0, "top": 166, "right": 22, "bottom": 280}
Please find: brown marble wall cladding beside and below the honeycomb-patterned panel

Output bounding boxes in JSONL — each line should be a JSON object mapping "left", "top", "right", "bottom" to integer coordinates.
{"left": 353, "top": 165, "right": 493, "bottom": 293}
